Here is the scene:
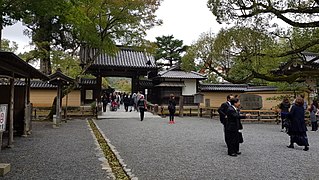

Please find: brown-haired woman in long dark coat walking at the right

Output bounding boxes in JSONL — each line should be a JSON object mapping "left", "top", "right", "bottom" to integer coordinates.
{"left": 287, "top": 97, "right": 309, "bottom": 151}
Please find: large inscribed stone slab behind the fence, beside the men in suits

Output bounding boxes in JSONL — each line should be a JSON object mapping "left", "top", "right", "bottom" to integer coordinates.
{"left": 239, "top": 94, "right": 263, "bottom": 110}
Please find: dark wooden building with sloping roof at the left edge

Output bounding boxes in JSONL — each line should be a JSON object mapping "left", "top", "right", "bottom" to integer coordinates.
{"left": 0, "top": 51, "right": 48, "bottom": 146}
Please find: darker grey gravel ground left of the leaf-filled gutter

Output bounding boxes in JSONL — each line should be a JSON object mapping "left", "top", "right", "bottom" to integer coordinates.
{"left": 0, "top": 120, "right": 111, "bottom": 180}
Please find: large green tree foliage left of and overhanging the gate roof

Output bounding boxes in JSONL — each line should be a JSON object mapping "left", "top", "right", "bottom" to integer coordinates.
{"left": 23, "top": 0, "right": 161, "bottom": 74}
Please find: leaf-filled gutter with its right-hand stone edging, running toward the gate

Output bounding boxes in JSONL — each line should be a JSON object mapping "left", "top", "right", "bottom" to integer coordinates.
{"left": 88, "top": 120, "right": 138, "bottom": 180}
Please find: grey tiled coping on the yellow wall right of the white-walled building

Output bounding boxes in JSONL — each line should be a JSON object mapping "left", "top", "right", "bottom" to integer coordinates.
{"left": 199, "top": 84, "right": 277, "bottom": 92}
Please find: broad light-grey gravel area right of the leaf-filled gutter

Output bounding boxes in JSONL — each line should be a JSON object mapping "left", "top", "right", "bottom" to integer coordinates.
{"left": 96, "top": 117, "right": 319, "bottom": 180}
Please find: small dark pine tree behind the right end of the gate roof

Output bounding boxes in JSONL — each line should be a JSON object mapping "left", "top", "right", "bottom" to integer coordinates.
{"left": 155, "top": 35, "right": 187, "bottom": 66}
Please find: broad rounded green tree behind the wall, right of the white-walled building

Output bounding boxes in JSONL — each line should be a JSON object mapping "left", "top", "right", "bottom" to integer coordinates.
{"left": 182, "top": 27, "right": 292, "bottom": 83}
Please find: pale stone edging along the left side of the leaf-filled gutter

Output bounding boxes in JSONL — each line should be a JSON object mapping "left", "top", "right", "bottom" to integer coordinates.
{"left": 87, "top": 121, "right": 116, "bottom": 179}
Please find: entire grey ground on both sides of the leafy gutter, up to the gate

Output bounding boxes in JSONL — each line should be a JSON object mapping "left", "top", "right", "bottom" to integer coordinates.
{"left": 0, "top": 107, "right": 319, "bottom": 180}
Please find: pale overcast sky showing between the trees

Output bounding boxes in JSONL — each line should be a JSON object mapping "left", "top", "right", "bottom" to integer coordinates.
{"left": 2, "top": 0, "right": 221, "bottom": 52}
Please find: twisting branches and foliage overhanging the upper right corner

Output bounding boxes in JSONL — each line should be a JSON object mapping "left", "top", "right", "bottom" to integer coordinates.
{"left": 207, "top": 0, "right": 319, "bottom": 82}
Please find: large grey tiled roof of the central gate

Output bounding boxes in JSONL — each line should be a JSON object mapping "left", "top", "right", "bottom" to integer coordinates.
{"left": 80, "top": 47, "right": 157, "bottom": 69}
